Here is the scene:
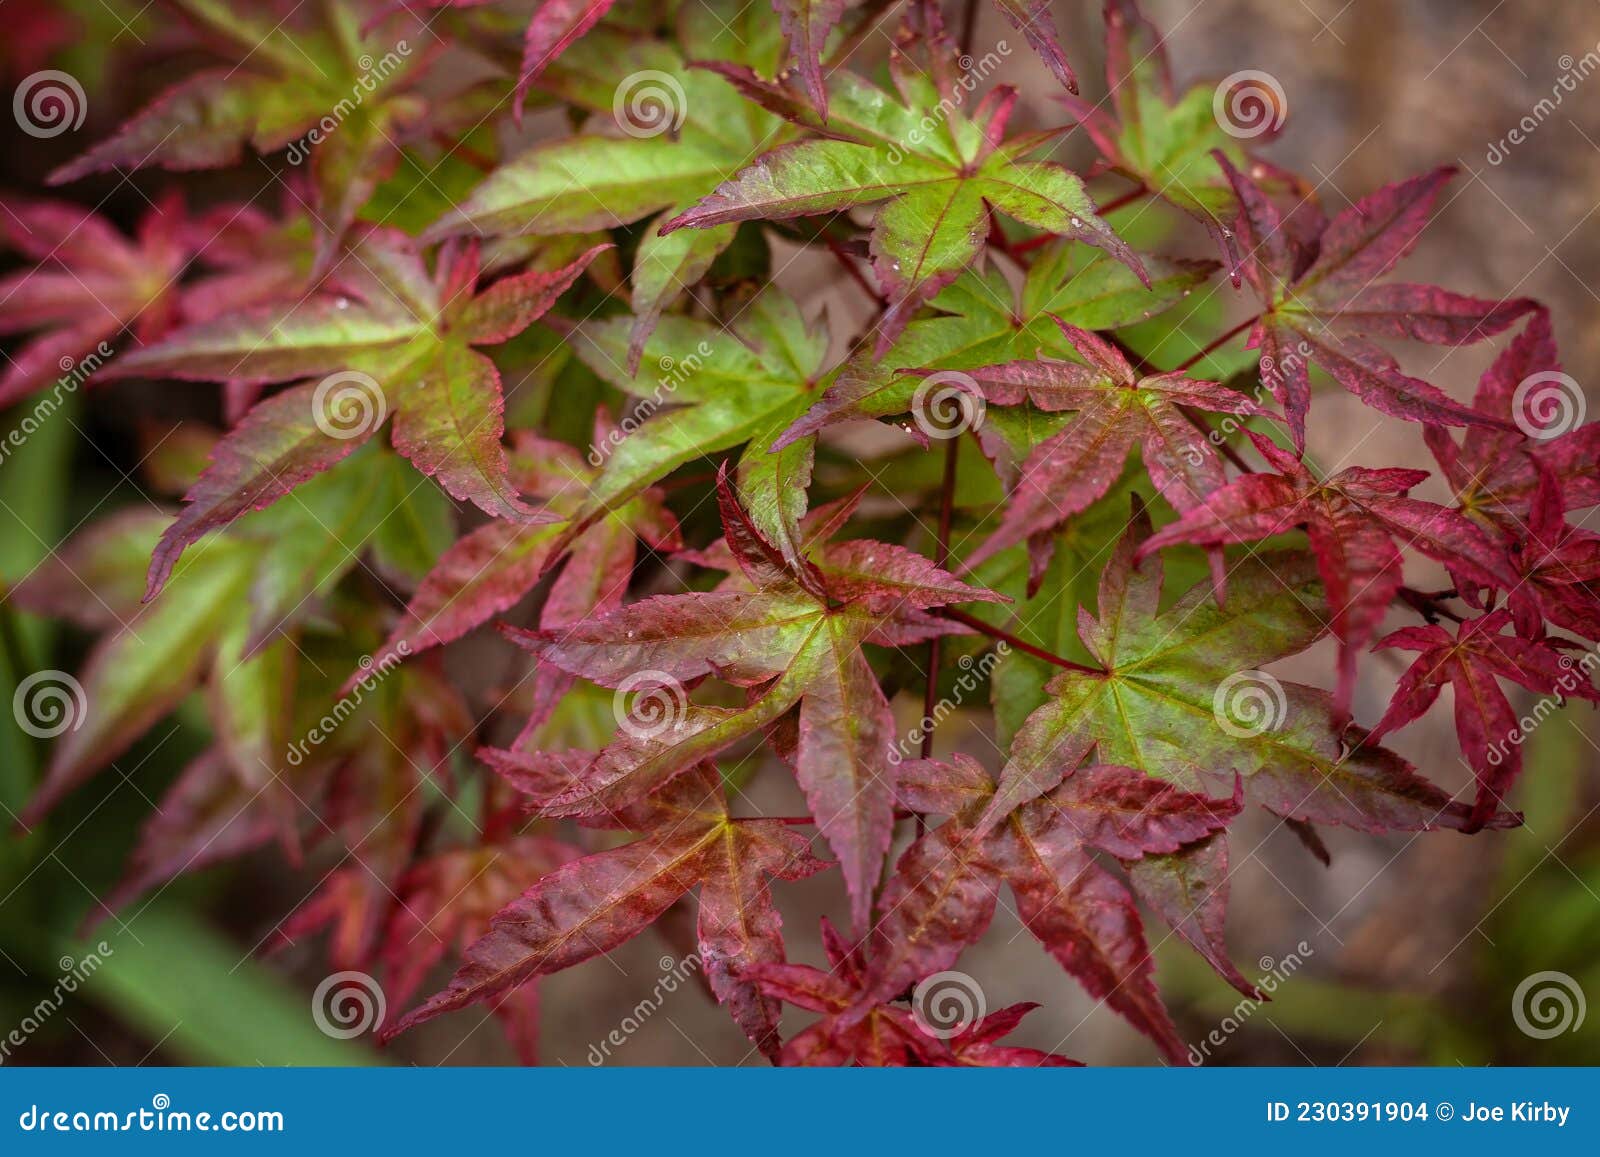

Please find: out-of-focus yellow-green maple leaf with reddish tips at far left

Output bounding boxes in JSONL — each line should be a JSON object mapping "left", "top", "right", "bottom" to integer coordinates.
{"left": 10, "top": 446, "right": 438, "bottom": 824}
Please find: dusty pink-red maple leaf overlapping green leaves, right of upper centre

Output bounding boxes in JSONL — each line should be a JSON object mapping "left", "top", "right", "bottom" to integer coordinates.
{"left": 940, "top": 318, "right": 1264, "bottom": 568}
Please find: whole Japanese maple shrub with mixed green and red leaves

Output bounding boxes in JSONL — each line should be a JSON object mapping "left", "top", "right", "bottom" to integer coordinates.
{"left": 0, "top": 0, "right": 1600, "bottom": 1066}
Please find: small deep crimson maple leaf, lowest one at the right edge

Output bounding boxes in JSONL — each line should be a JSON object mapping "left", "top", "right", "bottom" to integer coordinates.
{"left": 1373, "top": 610, "right": 1600, "bottom": 832}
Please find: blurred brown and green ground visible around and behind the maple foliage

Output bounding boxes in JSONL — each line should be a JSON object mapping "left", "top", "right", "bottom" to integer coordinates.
{"left": 0, "top": 0, "right": 1600, "bottom": 1066}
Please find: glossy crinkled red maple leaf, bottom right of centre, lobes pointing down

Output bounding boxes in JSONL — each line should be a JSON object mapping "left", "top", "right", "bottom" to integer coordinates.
{"left": 858, "top": 755, "right": 1242, "bottom": 1063}
